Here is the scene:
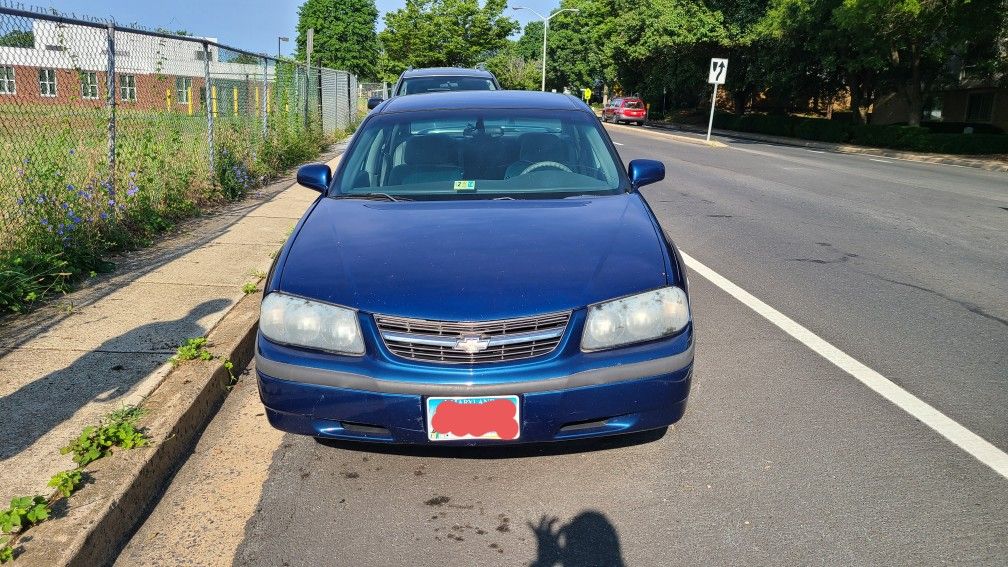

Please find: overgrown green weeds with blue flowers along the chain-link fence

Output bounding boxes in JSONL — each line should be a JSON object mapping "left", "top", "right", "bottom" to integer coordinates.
{"left": 0, "top": 104, "right": 326, "bottom": 314}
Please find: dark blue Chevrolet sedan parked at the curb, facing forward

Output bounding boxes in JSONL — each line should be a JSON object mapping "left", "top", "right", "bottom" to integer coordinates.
{"left": 256, "top": 91, "right": 694, "bottom": 445}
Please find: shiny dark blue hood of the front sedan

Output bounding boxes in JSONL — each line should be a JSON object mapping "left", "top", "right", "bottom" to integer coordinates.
{"left": 277, "top": 194, "right": 667, "bottom": 321}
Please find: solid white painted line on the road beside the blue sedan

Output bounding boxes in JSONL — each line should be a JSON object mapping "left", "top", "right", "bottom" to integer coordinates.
{"left": 680, "top": 251, "right": 1008, "bottom": 478}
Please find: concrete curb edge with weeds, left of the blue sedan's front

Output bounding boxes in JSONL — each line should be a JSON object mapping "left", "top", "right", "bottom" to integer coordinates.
{"left": 17, "top": 292, "right": 262, "bottom": 567}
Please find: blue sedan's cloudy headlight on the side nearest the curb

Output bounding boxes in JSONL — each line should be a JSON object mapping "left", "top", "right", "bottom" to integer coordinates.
{"left": 259, "top": 293, "right": 364, "bottom": 355}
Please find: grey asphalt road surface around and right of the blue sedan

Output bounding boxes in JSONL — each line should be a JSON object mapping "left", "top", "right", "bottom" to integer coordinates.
{"left": 119, "top": 127, "right": 1008, "bottom": 566}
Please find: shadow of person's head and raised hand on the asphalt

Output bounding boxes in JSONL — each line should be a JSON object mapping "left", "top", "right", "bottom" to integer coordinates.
{"left": 528, "top": 511, "right": 624, "bottom": 567}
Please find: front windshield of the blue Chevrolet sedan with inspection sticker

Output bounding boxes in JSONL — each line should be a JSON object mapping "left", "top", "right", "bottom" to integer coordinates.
{"left": 334, "top": 109, "right": 629, "bottom": 199}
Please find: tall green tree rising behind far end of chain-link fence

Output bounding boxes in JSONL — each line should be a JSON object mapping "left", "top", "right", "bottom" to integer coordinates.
{"left": 296, "top": 0, "right": 380, "bottom": 78}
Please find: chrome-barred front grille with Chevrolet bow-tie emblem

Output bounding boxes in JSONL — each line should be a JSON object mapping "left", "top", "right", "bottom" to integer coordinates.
{"left": 375, "top": 312, "right": 571, "bottom": 364}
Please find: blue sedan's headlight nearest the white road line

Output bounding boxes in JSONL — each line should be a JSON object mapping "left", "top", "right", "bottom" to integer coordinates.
{"left": 581, "top": 288, "right": 689, "bottom": 350}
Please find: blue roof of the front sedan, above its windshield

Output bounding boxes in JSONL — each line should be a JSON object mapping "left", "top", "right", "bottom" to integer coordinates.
{"left": 375, "top": 91, "right": 594, "bottom": 115}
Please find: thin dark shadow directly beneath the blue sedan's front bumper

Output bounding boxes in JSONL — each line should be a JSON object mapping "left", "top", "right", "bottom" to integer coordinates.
{"left": 316, "top": 428, "right": 668, "bottom": 459}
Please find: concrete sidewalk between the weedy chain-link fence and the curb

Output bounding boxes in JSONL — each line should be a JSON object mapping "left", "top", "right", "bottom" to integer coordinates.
{"left": 0, "top": 148, "right": 338, "bottom": 501}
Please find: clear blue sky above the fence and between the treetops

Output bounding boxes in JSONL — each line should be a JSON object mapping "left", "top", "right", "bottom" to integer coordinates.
{"left": 45, "top": 0, "right": 559, "bottom": 55}
